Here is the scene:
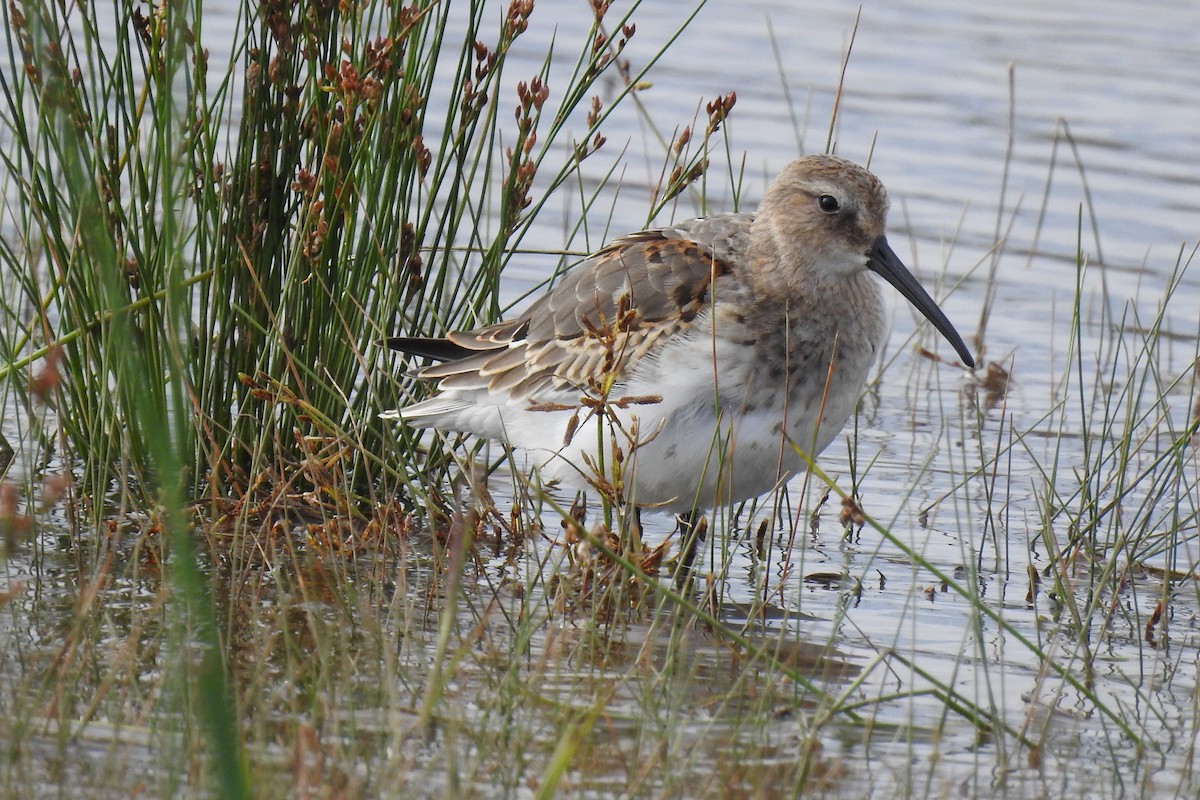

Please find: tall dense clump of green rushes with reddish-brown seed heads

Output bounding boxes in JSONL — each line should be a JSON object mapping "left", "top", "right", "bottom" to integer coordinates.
{"left": 0, "top": 2, "right": 702, "bottom": 521}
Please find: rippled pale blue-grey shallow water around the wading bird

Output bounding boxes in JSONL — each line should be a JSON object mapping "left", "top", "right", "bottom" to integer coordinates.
{"left": 5, "top": 0, "right": 1200, "bottom": 796}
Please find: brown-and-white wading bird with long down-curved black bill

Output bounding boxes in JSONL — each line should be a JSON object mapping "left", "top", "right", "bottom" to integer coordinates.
{"left": 380, "top": 155, "right": 974, "bottom": 517}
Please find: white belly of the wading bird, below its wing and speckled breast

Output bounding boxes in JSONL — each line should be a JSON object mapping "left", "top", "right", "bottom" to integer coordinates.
{"left": 504, "top": 326, "right": 874, "bottom": 512}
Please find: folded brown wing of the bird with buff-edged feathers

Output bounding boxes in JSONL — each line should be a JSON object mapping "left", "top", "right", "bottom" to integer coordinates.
{"left": 390, "top": 215, "right": 751, "bottom": 403}
